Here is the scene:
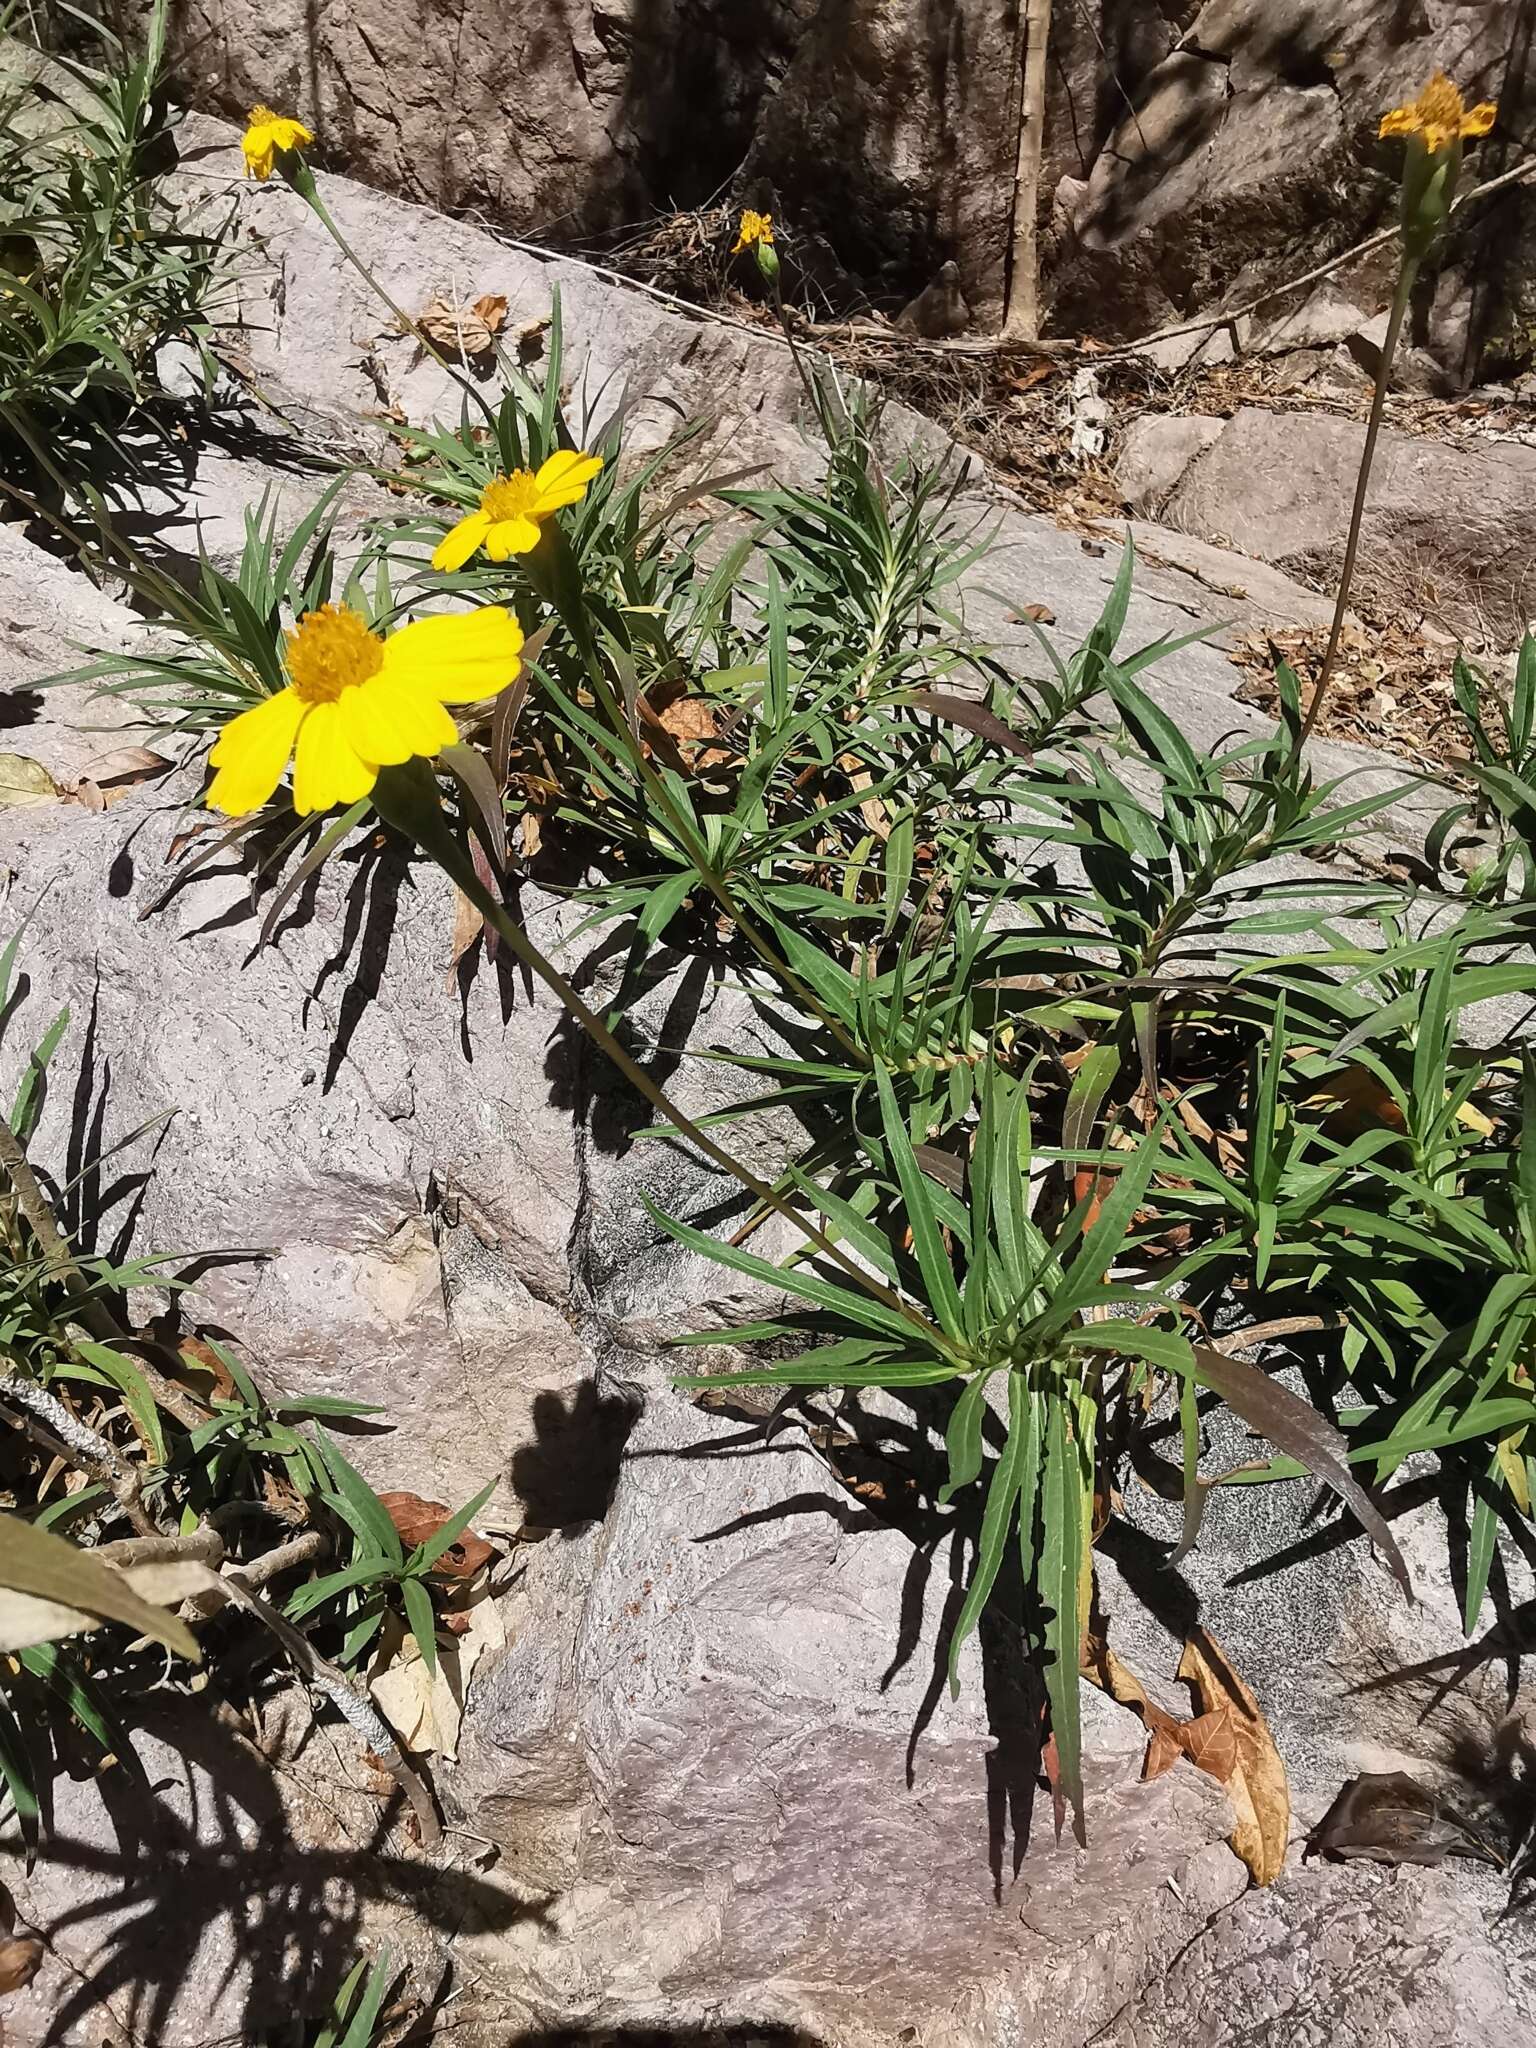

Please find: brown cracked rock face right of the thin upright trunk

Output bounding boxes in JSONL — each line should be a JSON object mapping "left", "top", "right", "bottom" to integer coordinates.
{"left": 1042, "top": 0, "right": 1536, "bottom": 364}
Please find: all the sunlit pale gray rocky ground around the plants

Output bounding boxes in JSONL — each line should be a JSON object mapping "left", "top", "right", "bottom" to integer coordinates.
{"left": 0, "top": 108, "right": 1536, "bottom": 2048}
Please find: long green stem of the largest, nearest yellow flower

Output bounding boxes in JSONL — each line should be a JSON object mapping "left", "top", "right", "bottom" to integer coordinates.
{"left": 373, "top": 760, "right": 950, "bottom": 1372}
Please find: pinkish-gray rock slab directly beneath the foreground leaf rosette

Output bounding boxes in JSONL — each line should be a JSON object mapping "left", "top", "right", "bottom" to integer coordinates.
{"left": 442, "top": 1354, "right": 1241, "bottom": 2048}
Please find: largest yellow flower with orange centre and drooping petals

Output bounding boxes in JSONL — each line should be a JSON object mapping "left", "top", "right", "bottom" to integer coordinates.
{"left": 207, "top": 604, "right": 522, "bottom": 817}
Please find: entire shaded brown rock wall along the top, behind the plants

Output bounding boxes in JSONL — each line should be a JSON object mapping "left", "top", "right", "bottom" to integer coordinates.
{"left": 159, "top": 0, "right": 1536, "bottom": 369}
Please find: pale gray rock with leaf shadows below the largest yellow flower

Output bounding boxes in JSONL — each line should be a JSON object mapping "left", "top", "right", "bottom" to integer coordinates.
{"left": 0, "top": 782, "right": 582, "bottom": 1499}
